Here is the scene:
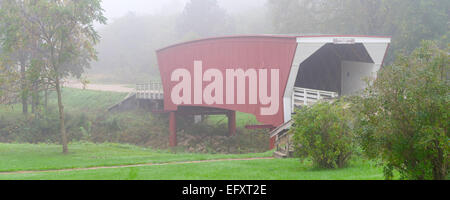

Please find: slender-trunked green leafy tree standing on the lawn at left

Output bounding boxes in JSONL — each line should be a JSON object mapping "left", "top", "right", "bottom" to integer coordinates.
{"left": 30, "top": 0, "right": 106, "bottom": 153}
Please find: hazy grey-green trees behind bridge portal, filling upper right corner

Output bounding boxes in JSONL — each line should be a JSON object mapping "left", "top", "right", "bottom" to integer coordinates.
{"left": 268, "top": 0, "right": 450, "bottom": 63}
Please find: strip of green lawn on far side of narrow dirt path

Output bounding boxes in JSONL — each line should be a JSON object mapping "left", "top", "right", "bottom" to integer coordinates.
{"left": 0, "top": 143, "right": 272, "bottom": 172}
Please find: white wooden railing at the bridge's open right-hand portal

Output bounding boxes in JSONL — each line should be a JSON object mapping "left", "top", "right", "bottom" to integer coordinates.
{"left": 292, "top": 87, "right": 339, "bottom": 106}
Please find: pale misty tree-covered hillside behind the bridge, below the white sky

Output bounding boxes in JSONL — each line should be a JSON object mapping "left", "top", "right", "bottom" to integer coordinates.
{"left": 89, "top": 0, "right": 273, "bottom": 84}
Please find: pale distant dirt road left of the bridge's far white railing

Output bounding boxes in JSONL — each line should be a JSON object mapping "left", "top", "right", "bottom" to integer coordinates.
{"left": 64, "top": 80, "right": 134, "bottom": 93}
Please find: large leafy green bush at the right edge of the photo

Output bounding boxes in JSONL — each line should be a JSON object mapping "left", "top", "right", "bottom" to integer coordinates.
{"left": 355, "top": 41, "right": 450, "bottom": 179}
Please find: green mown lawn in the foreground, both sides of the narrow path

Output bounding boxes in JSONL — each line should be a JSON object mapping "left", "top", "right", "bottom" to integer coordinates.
{"left": 0, "top": 144, "right": 383, "bottom": 180}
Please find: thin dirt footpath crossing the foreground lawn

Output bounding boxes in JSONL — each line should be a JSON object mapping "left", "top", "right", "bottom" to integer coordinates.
{"left": 0, "top": 157, "right": 274, "bottom": 175}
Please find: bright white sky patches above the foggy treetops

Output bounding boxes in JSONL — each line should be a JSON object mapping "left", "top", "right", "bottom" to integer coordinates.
{"left": 102, "top": 0, "right": 266, "bottom": 22}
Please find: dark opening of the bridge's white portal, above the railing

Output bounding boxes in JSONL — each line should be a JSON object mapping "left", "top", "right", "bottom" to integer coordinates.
{"left": 295, "top": 43, "right": 378, "bottom": 95}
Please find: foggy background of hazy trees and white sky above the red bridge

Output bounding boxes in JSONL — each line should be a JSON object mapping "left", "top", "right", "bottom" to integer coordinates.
{"left": 89, "top": 0, "right": 450, "bottom": 84}
